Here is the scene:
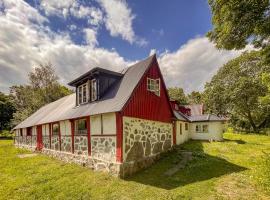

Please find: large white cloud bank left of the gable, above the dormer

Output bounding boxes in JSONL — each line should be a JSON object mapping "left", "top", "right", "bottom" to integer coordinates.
{"left": 0, "top": 1, "right": 128, "bottom": 92}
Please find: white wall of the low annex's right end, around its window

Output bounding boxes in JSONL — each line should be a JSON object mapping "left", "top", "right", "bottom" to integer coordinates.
{"left": 190, "top": 122, "right": 224, "bottom": 141}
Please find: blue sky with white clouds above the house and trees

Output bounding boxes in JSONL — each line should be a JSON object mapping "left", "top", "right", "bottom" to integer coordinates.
{"left": 0, "top": 0, "right": 249, "bottom": 93}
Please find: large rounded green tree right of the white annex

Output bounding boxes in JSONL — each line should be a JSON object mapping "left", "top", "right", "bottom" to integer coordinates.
{"left": 204, "top": 51, "right": 270, "bottom": 132}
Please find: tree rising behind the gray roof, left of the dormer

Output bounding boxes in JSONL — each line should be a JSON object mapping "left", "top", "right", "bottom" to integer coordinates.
{"left": 10, "top": 63, "right": 72, "bottom": 125}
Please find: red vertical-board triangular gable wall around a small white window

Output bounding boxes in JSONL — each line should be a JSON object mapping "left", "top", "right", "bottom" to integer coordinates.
{"left": 123, "top": 58, "right": 173, "bottom": 122}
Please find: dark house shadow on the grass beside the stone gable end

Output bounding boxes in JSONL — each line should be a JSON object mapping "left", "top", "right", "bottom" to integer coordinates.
{"left": 125, "top": 141, "right": 247, "bottom": 190}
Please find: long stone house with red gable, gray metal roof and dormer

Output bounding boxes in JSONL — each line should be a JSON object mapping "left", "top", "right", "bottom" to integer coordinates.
{"left": 15, "top": 55, "right": 176, "bottom": 176}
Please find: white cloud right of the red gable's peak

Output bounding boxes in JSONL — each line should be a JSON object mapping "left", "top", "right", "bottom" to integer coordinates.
{"left": 158, "top": 37, "right": 251, "bottom": 93}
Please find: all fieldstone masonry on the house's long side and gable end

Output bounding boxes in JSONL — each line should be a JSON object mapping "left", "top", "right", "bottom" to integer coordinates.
{"left": 15, "top": 117, "right": 172, "bottom": 177}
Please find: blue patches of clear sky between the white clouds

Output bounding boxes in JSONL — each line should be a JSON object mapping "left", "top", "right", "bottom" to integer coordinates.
{"left": 27, "top": 0, "right": 211, "bottom": 60}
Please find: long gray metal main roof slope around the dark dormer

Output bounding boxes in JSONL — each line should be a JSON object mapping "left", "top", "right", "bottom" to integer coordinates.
{"left": 14, "top": 55, "right": 156, "bottom": 129}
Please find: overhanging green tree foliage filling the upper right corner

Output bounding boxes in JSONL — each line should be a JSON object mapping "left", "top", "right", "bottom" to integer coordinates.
{"left": 207, "top": 0, "right": 270, "bottom": 63}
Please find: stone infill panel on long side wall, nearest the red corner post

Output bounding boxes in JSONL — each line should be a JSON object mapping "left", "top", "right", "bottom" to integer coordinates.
{"left": 91, "top": 136, "right": 116, "bottom": 162}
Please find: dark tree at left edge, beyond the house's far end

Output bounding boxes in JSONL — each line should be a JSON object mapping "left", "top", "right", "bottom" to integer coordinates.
{"left": 0, "top": 92, "right": 15, "bottom": 131}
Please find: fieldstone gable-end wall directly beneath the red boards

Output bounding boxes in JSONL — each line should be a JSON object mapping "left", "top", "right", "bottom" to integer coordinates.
{"left": 123, "top": 117, "right": 173, "bottom": 162}
